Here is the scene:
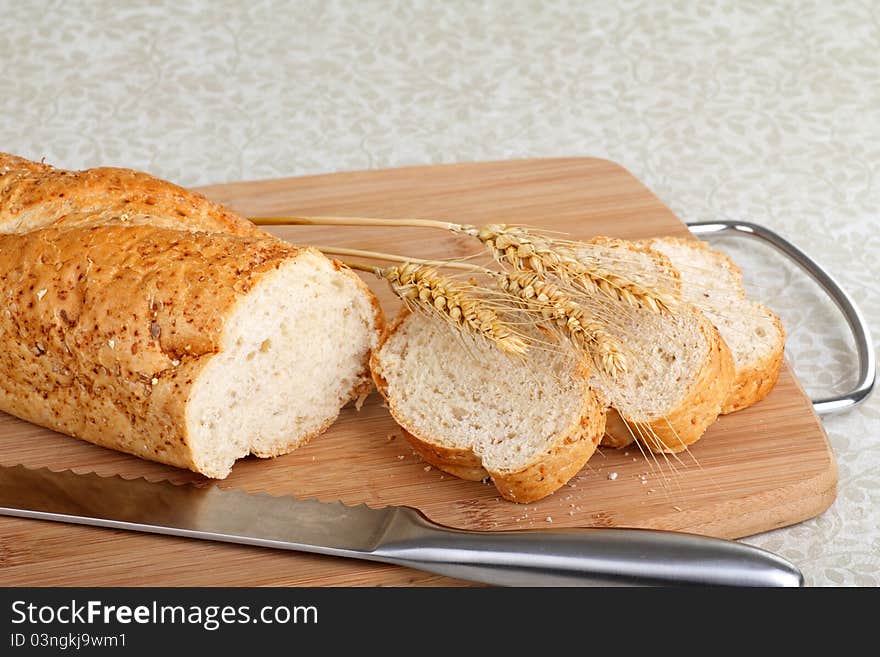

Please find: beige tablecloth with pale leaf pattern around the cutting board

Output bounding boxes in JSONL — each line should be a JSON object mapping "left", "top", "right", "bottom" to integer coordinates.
{"left": 0, "top": 0, "right": 880, "bottom": 585}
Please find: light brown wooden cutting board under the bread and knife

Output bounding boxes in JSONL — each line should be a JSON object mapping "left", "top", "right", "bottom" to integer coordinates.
{"left": 0, "top": 159, "right": 837, "bottom": 586}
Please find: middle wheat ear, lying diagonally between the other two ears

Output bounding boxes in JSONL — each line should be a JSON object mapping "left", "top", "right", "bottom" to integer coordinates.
{"left": 495, "top": 272, "right": 627, "bottom": 376}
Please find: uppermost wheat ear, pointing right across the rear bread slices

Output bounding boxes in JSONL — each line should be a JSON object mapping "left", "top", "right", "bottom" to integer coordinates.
{"left": 464, "top": 224, "right": 675, "bottom": 313}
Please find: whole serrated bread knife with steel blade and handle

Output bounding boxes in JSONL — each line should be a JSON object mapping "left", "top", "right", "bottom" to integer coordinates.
{"left": 0, "top": 466, "right": 803, "bottom": 586}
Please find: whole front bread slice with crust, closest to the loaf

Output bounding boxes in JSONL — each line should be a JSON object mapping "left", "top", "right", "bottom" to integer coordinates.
{"left": 371, "top": 312, "right": 605, "bottom": 503}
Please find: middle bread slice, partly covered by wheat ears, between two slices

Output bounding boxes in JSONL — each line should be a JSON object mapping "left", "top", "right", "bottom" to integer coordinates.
{"left": 581, "top": 238, "right": 733, "bottom": 453}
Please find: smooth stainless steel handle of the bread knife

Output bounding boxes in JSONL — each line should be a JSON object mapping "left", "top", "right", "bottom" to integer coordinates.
{"left": 370, "top": 507, "right": 803, "bottom": 586}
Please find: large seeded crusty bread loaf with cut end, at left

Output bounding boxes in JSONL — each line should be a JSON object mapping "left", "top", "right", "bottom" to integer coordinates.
{"left": 0, "top": 155, "right": 382, "bottom": 478}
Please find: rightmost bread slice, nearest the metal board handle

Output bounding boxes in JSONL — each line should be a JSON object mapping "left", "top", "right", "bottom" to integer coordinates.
{"left": 646, "top": 237, "right": 785, "bottom": 413}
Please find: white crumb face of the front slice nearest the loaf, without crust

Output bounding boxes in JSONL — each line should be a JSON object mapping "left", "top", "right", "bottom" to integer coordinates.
{"left": 378, "top": 314, "right": 591, "bottom": 472}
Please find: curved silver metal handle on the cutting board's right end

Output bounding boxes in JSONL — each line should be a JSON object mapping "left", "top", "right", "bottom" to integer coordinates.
{"left": 687, "top": 221, "right": 877, "bottom": 415}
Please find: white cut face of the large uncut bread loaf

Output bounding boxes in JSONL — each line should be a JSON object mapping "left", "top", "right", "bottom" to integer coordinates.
{"left": 186, "top": 250, "right": 378, "bottom": 478}
